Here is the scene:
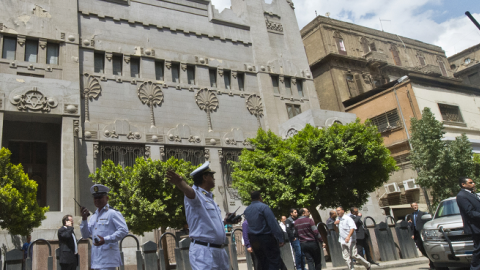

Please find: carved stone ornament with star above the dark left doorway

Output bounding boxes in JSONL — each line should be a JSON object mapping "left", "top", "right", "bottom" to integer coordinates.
{"left": 11, "top": 87, "right": 58, "bottom": 112}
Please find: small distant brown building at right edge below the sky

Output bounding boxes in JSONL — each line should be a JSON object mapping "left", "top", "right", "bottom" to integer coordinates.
{"left": 448, "top": 44, "right": 480, "bottom": 86}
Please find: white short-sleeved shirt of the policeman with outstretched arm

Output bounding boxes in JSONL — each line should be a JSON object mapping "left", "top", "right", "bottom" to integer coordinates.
{"left": 184, "top": 185, "right": 226, "bottom": 245}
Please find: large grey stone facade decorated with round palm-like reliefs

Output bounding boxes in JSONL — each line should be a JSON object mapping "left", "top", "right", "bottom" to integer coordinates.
{"left": 0, "top": 0, "right": 355, "bottom": 268}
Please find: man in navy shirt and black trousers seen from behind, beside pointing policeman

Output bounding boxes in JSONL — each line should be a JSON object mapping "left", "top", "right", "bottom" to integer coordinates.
{"left": 244, "top": 191, "right": 285, "bottom": 270}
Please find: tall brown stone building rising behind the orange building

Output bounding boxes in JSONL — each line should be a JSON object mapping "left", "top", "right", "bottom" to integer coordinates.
{"left": 301, "top": 16, "right": 453, "bottom": 111}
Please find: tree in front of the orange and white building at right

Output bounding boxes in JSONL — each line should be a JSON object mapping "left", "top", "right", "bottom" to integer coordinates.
{"left": 410, "top": 107, "right": 474, "bottom": 210}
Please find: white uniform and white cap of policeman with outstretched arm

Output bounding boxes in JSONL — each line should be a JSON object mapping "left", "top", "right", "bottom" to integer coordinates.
{"left": 184, "top": 161, "right": 229, "bottom": 270}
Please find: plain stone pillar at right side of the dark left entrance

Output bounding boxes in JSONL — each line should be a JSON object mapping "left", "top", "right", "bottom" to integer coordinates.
{"left": 60, "top": 116, "right": 78, "bottom": 213}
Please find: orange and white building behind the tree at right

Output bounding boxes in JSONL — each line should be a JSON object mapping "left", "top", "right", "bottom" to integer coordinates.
{"left": 345, "top": 73, "right": 480, "bottom": 219}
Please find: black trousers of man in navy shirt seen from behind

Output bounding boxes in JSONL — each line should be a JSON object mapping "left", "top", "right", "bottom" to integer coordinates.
{"left": 248, "top": 233, "right": 283, "bottom": 270}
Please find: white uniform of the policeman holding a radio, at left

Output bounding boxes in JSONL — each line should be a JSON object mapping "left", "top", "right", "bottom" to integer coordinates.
{"left": 80, "top": 204, "right": 128, "bottom": 269}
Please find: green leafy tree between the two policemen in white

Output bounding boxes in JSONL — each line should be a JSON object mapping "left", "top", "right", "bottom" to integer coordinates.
{"left": 90, "top": 157, "right": 195, "bottom": 235}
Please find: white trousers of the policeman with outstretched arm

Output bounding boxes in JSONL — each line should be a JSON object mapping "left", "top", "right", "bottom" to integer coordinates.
{"left": 188, "top": 243, "right": 230, "bottom": 270}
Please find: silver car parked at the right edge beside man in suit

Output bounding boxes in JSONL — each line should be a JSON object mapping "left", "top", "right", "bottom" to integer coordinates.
{"left": 421, "top": 197, "right": 474, "bottom": 270}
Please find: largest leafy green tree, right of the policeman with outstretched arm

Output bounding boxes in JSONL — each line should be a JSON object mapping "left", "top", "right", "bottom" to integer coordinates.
{"left": 231, "top": 119, "right": 396, "bottom": 223}
